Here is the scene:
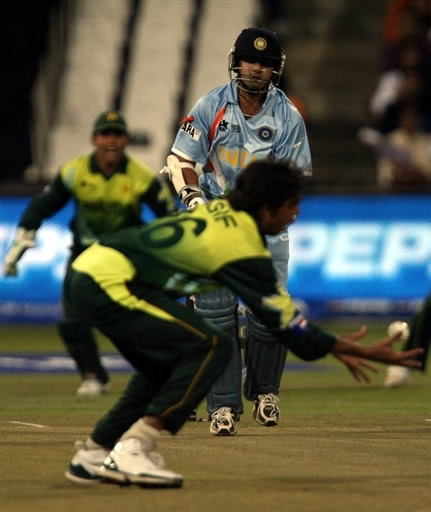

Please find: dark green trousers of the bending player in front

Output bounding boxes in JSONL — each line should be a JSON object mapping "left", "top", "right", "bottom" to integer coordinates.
{"left": 64, "top": 268, "right": 232, "bottom": 448}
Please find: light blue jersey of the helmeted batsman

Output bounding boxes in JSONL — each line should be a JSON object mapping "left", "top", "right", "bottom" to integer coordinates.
{"left": 171, "top": 82, "right": 312, "bottom": 199}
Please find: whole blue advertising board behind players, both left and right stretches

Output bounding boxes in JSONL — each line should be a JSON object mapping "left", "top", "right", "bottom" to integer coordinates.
{"left": 0, "top": 195, "right": 431, "bottom": 323}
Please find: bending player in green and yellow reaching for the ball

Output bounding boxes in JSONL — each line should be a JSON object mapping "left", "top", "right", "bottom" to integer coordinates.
{"left": 65, "top": 160, "right": 420, "bottom": 487}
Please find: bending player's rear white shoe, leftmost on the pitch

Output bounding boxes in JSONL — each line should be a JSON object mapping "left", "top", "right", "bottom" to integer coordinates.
{"left": 65, "top": 441, "right": 109, "bottom": 485}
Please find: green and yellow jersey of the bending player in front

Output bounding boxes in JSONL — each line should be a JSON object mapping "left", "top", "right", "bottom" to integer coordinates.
{"left": 72, "top": 199, "right": 335, "bottom": 359}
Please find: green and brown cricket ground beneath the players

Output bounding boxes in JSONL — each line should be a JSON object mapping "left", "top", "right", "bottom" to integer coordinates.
{"left": 0, "top": 320, "right": 431, "bottom": 512}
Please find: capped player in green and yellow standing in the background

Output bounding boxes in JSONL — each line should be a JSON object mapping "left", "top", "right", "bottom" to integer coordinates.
{"left": 4, "top": 111, "right": 176, "bottom": 395}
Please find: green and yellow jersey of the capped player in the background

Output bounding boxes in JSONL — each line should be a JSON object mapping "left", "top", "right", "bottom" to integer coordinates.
{"left": 19, "top": 153, "right": 176, "bottom": 252}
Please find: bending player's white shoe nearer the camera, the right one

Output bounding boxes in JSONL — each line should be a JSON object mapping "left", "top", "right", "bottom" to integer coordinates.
{"left": 100, "top": 437, "right": 183, "bottom": 487}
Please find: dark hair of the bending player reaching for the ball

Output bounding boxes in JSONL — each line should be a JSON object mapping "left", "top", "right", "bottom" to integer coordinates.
{"left": 228, "top": 160, "right": 304, "bottom": 214}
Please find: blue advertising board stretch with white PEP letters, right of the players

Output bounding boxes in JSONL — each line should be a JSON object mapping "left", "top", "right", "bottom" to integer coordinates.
{"left": 288, "top": 195, "right": 431, "bottom": 316}
